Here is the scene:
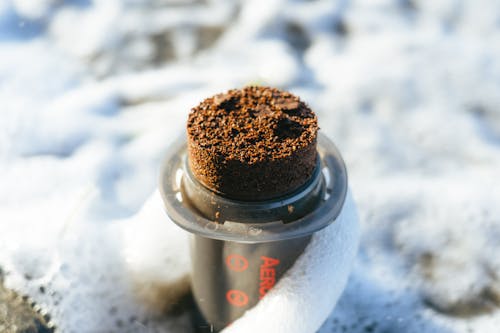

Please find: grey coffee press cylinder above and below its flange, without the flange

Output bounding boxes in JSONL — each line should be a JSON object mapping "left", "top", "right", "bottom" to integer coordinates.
{"left": 181, "top": 159, "right": 325, "bottom": 332}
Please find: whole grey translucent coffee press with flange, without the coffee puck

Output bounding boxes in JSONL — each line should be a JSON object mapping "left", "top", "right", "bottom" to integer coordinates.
{"left": 160, "top": 135, "right": 347, "bottom": 332}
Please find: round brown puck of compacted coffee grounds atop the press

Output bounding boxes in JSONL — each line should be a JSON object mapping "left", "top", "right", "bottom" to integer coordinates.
{"left": 187, "top": 86, "right": 318, "bottom": 201}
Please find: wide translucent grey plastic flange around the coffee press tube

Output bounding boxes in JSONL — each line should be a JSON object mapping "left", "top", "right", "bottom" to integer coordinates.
{"left": 159, "top": 133, "right": 348, "bottom": 243}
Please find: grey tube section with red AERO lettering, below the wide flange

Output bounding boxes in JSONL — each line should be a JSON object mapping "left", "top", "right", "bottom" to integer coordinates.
{"left": 191, "top": 235, "right": 310, "bottom": 332}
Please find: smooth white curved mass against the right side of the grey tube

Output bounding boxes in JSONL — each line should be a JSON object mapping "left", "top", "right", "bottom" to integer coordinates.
{"left": 223, "top": 189, "right": 359, "bottom": 333}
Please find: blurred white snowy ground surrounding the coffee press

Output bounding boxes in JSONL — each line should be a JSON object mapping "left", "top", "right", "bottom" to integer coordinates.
{"left": 0, "top": 0, "right": 500, "bottom": 333}
